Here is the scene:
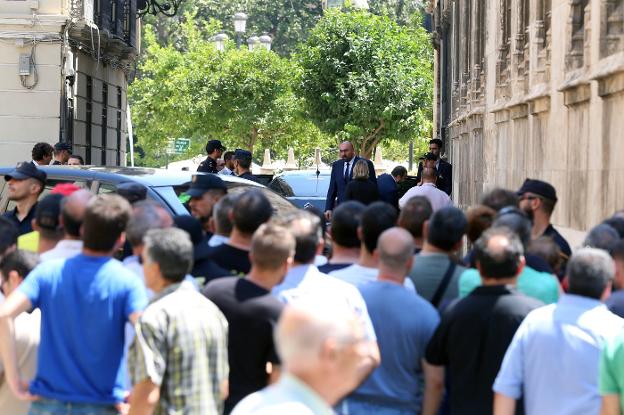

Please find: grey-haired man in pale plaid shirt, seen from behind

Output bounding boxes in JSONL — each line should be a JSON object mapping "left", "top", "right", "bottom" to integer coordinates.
{"left": 128, "top": 228, "right": 229, "bottom": 415}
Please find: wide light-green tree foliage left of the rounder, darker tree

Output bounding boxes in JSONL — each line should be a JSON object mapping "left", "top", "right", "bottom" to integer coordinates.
{"left": 129, "top": 18, "right": 327, "bottom": 165}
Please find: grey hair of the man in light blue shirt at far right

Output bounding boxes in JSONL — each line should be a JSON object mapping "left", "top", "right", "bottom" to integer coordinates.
{"left": 567, "top": 248, "right": 615, "bottom": 299}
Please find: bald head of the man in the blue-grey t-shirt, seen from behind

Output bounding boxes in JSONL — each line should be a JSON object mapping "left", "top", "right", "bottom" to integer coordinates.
{"left": 377, "top": 227, "right": 414, "bottom": 278}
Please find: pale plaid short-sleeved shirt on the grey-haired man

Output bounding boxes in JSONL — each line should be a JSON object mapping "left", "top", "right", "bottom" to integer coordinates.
{"left": 128, "top": 283, "right": 228, "bottom": 415}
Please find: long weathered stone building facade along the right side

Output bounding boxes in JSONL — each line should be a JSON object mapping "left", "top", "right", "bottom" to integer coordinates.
{"left": 431, "top": 0, "right": 624, "bottom": 241}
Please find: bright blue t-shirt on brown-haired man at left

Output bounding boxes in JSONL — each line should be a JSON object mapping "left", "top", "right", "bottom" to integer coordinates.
{"left": 18, "top": 254, "right": 147, "bottom": 404}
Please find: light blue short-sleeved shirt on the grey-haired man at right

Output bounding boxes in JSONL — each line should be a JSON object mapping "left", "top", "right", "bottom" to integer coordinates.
{"left": 493, "top": 294, "right": 624, "bottom": 415}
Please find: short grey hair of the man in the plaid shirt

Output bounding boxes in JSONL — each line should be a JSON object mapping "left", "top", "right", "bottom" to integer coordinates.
{"left": 143, "top": 228, "right": 193, "bottom": 282}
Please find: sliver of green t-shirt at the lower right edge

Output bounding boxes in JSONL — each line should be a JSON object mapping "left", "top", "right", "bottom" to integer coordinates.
{"left": 599, "top": 333, "right": 624, "bottom": 408}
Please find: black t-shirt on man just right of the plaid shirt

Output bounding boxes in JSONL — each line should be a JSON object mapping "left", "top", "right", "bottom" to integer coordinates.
{"left": 204, "top": 277, "right": 284, "bottom": 414}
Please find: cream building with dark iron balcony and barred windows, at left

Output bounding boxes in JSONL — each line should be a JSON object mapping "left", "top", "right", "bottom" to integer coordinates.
{"left": 0, "top": 0, "right": 139, "bottom": 165}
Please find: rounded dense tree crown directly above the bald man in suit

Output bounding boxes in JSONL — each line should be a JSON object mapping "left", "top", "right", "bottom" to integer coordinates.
{"left": 297, "top": 10, "right": 433, "bottom": 157}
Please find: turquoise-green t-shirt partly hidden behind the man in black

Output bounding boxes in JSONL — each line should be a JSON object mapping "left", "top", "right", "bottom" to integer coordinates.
{"left": 459, "top": 266, "right": 559, "bottom": 304}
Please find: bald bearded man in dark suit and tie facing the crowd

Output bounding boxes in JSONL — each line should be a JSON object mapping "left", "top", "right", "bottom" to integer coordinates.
{"left": 325, "top": 141, "right": 377, "bottom": 220}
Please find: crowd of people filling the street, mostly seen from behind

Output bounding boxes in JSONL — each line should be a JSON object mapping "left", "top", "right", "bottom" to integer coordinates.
{"left": 0, "top": 142, "right": 624, "bottom": 415}
